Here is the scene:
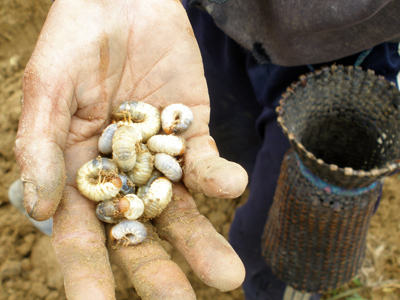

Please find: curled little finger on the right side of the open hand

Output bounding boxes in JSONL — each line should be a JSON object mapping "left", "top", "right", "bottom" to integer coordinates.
{"left": 183, "top": 135, "right": 248, "bottom": 198}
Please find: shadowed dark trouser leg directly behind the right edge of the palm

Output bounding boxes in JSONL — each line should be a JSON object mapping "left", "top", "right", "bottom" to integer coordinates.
{"left": 183, "top": 1, "right": 262, "bottom": 172}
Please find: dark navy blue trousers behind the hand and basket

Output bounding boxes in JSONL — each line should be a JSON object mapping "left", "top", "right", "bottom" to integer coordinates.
{"left": 183, "top": 1, "right": 400, "bottom": 300}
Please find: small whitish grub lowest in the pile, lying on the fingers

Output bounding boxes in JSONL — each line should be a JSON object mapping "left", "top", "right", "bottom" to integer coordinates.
{"left": 110, "top": 220, "right": 147, "bottom": 246}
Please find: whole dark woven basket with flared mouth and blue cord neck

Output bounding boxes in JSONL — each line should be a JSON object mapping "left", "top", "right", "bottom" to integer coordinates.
{"left": 262, "top": 66, "right": 400, "bottom": 293}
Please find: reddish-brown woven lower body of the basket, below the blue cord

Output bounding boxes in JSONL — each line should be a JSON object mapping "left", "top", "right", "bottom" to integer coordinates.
{"left": 263, "top": 151, "right": 381, "bottom": 293}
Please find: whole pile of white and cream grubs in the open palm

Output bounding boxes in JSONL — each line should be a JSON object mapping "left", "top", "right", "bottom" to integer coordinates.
{"left": 77, "top": 101, "right": 193, "bottom": 245}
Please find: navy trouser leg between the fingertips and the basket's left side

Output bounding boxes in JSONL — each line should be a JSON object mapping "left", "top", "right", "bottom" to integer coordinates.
{"left": 229, "top": 114, "right": 289, "bottom": 300}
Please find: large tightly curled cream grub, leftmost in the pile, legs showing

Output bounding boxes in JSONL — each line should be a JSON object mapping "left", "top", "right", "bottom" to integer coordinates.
{"left": 76, "top": 158, "right": 122, "bottom": 201}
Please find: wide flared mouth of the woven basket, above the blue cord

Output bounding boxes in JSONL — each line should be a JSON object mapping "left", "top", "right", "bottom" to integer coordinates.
{"left": 277, "top": 66, "right": 400, "bottom": 188}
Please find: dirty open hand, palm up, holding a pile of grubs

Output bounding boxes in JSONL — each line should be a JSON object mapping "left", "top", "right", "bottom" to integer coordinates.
{"left": 15, "top": 0, "right": 247, "bottom": 299}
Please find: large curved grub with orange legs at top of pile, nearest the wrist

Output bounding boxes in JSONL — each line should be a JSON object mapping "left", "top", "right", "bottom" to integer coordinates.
{"left": 115, "top": 101, "right": 161, "bottom": 143}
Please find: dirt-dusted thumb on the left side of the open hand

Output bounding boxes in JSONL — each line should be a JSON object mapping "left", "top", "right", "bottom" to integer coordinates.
{"left": 15, "top": 65, "right": 71, "bottom": 221}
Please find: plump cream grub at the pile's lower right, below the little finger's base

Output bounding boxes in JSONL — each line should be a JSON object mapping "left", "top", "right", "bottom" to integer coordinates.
{"left": 142, "top": 177, "right": 172, "bottom": 219}
